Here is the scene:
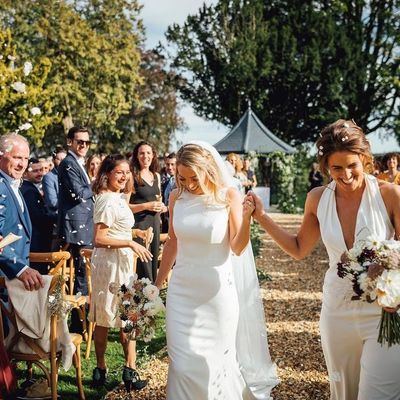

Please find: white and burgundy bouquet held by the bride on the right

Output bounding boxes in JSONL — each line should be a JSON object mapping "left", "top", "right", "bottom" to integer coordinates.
{"left": 337, "top": 238, "right": 400, "bottom": 347}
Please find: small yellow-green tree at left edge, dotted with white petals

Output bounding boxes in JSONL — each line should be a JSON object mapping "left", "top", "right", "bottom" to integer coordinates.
{"left": 0, "top": 30, "right": 58, "bottom": 146}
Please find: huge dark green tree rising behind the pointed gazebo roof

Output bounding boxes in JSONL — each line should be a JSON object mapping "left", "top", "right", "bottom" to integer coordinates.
{"left": 166, "top": 0, "right": 400, "bottom": 144}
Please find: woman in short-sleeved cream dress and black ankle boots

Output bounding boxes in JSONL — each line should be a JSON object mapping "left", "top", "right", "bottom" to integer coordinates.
{"left": 89, "top": 155, "right": 151, "bottom": 390}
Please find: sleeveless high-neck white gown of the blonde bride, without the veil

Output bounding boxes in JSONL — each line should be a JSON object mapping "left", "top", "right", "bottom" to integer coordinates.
{"left": 166, "top": 192, "right": 253, "bottom": 400}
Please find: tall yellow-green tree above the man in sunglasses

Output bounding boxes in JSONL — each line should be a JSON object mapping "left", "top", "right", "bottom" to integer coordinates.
{"left": 0, "top": 0, "right": 142, "bottom": 144}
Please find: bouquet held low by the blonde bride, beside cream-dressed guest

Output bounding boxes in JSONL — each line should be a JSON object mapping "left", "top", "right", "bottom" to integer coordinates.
{"left": 109, "top": 274, "right": 165, "bottom": 342}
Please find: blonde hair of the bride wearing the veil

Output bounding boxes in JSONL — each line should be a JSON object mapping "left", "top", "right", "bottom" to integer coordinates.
{"left": 176, "top": 144, "right": 226, "bottom": 204}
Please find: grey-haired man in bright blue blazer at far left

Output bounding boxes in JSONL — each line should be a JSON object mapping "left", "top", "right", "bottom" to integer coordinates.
{"left": 0, "top": 133, "right": 44, "bottom": 290}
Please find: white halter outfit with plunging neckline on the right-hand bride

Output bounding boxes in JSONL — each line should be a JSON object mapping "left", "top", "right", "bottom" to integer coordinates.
{"left": 317, "top": 175, "right": 400, "bottom": 400}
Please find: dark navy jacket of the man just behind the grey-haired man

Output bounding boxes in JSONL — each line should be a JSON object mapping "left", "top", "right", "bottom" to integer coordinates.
{"left": 21, "top": 181, "right": 57, "bottom": 252}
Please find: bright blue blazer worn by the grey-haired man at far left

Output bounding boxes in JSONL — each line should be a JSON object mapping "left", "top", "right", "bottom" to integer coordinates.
{"left": 0, "top": 171, "right": 32, "bottom": 279}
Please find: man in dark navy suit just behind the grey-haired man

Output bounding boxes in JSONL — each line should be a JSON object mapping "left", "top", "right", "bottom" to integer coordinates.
{"left": 21, "top": 158, "right": 57, "bottom": 275}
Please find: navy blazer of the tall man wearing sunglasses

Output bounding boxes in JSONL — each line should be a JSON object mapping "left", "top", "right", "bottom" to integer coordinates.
{"left": 58, "top": 153, "right": 94, "bottom": 245}
